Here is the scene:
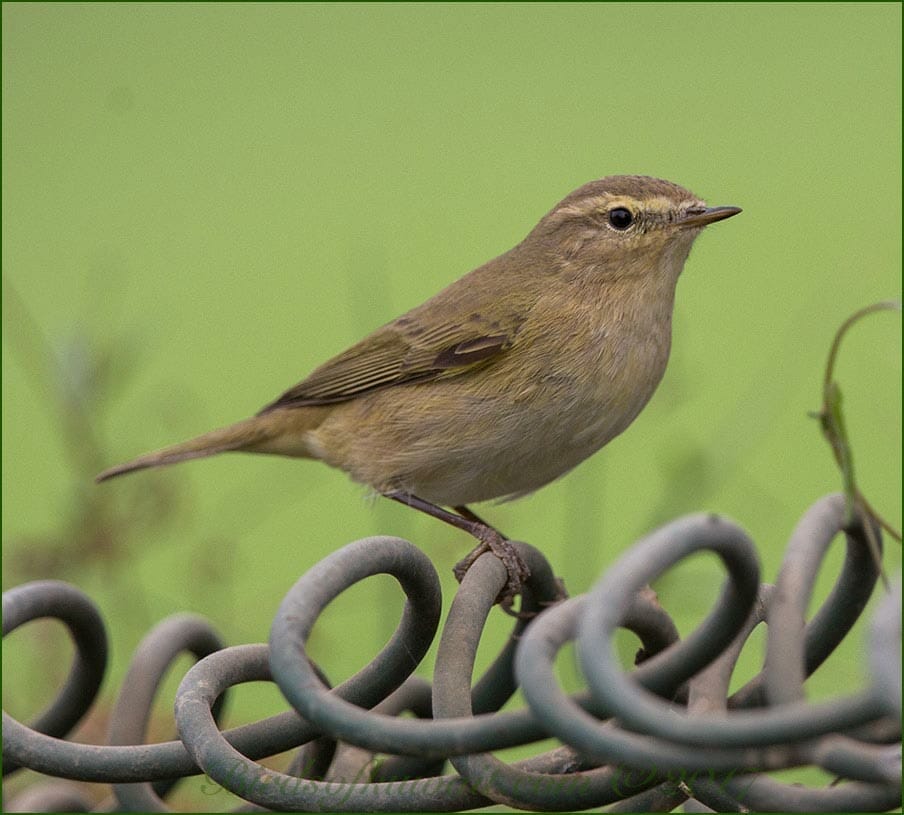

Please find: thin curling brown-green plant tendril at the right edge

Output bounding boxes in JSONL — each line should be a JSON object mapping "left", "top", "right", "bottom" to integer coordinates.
{"left": 811, "top": 300, "right": 901, "bottom": 589}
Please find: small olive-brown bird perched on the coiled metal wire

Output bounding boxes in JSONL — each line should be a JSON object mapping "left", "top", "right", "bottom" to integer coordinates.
{"left": 97, "top": 176, "right": 741, "bottom": 605}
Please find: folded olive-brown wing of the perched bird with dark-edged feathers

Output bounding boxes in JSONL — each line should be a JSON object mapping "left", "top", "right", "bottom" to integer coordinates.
{"left": 261, "top": 314, "right": 524, "bottom": 413}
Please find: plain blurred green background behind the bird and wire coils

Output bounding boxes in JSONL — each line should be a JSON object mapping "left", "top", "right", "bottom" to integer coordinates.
{"left": 3, "top": 3, "right": 901, "bottom": 808}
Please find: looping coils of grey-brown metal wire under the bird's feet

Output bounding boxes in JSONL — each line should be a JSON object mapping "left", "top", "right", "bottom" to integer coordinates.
{"left": 3, "top": 495, "right": 901, "bottom": 812}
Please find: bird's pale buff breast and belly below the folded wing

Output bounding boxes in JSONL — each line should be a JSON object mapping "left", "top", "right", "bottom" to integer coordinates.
{"left": 314, "top": 286, "right": 668, "bottom": 506}
